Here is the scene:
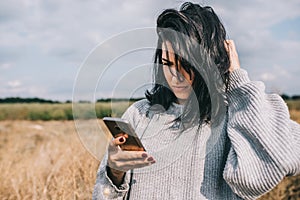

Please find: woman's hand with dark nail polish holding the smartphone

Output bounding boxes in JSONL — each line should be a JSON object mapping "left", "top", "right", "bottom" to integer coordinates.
{"left": 107, "top": 136, "right": 155, "bottom": 186}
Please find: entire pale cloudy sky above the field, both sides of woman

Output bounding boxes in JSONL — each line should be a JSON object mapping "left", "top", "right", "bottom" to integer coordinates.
{"left": 0, "top": 0, "right": 300, "bottom": 101}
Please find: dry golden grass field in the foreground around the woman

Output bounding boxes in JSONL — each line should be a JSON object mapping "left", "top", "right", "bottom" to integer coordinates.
{"left": 0, "top": 106, "right": 300, "bottom": 200}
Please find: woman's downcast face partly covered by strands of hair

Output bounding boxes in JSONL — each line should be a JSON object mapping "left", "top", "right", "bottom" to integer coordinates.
{"left": 162, "top": 41, "right": 194, "bottom": 104}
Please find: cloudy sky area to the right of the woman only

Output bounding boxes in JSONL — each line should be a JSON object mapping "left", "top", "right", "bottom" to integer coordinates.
{"left": 206, "top": 0, "right": 300, "bottom": 94}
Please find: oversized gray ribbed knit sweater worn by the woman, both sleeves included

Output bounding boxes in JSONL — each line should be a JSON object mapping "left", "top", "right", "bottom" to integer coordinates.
{"left": 93, "top": 69, "right": 300, "bottom": 200}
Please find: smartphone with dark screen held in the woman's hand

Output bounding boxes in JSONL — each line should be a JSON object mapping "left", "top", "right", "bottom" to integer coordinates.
{"left": 103, "top": 117, "right": 146, "bottom": 151}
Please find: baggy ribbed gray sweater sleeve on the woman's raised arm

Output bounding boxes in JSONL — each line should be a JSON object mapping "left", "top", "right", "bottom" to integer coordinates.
{"left": 223, "top": 69, "right": 300, "bottom": 199}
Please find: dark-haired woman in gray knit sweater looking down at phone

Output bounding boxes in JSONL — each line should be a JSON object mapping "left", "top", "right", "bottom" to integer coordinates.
{"left": 93, "top": 3, "right": 300, "bottom": 199}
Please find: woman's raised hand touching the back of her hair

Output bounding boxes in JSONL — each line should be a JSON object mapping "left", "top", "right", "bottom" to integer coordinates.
{"left": 224, "top": 40, "right": 240, "bottom": 72}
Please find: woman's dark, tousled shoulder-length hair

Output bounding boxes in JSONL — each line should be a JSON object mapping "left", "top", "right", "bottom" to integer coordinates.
{"left": 145, "top": 2, "right": 230, "bottom": 124}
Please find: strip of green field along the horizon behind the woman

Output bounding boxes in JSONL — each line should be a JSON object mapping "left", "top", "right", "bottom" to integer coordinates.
{"left": 0, "top": 100, "right": 300, "bottom": 121}
